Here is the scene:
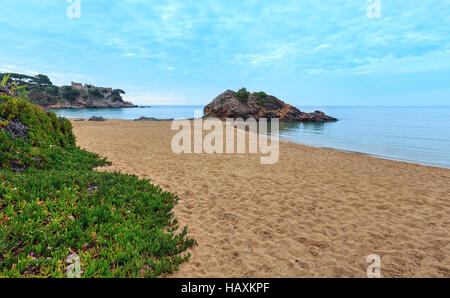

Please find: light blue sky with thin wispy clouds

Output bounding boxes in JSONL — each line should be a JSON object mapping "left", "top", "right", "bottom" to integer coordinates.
{"left": 0, "top": 0, "right": 450, "bottom": 106}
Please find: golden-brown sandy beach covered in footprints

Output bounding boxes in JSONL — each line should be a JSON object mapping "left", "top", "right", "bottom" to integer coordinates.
{"left": 72, "top": 120, "right": 450, "bottom": 277}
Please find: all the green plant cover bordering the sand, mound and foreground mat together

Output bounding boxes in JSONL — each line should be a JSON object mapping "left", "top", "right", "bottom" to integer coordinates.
{"left": 0, "top": 96, "right": 195, "bottom": 277}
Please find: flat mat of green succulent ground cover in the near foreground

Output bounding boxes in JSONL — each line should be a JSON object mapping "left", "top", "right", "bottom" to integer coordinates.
{"left": 0, "top": 170, "right": 194, "bottom": 277}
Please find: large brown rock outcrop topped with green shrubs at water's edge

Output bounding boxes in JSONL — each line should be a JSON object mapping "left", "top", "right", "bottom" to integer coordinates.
{"left": 204, "top": 90, "right": 337, "bottom": 122}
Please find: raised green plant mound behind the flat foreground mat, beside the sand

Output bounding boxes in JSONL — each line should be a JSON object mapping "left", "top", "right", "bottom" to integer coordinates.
{"left": 0, "top": 96, "right": 108, "bottom": 170}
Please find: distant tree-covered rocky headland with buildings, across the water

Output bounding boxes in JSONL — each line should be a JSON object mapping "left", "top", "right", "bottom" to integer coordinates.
{"left": 0, "top": 73, "right": 135, "bottom": 109}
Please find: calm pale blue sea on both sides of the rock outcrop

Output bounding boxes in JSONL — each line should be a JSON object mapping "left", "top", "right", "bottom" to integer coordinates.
{"left": 55, "top": 106, "right": 450, "bottom": 168}
